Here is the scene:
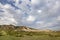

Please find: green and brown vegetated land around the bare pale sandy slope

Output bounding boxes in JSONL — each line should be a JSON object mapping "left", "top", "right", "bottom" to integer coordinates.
{"left": 0, "top": 25, "right": 60, "bottom": 40}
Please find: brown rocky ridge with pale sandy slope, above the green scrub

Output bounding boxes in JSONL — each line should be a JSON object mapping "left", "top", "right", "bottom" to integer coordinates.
{"left": 0, "top": 25, "right": 59, "bottom": 32}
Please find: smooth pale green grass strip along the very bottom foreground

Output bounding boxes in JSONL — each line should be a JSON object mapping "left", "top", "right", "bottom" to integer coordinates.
{"left": 0, "top": 35, "right": 60, "bottom": 40}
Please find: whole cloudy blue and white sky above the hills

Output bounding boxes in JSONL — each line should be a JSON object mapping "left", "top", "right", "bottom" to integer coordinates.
{"left": 0, "top": 0, "right": 60, "bottom": 30}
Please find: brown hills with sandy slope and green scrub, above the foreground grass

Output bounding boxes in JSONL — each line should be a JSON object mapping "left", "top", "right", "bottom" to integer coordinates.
{"left": 0, "top": 25, "right": 60, "bottom": 37}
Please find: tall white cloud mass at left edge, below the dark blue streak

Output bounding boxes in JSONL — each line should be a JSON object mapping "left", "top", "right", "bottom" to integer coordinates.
{"left": 0, "top": 3, "right": 17, "bottom": 25}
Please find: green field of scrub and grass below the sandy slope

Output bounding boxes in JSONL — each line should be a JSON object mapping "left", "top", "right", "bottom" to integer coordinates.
{"left": 0, "top": 32, "right": 60, "bottom": 40}
